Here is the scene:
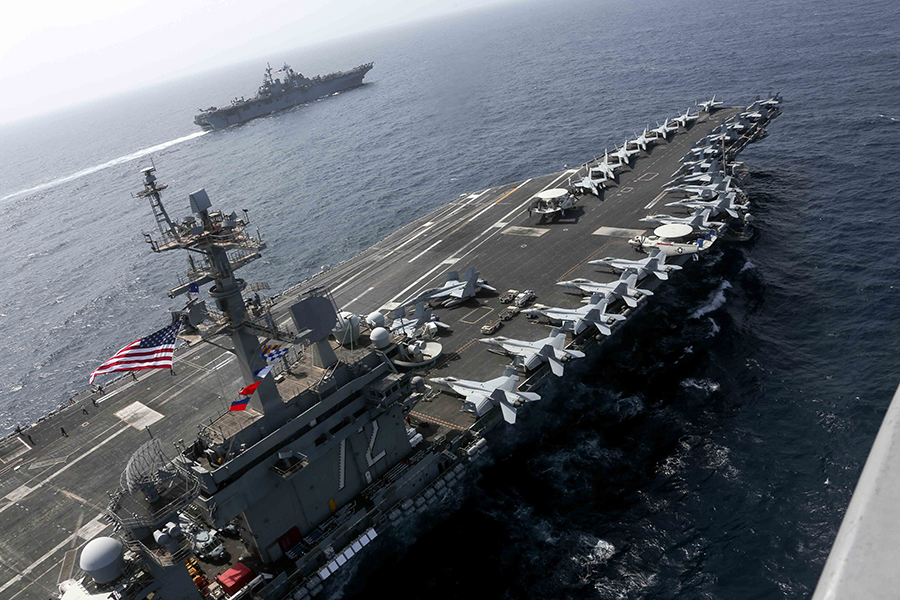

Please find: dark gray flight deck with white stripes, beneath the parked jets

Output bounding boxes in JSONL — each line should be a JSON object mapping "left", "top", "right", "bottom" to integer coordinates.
{"left": 0, "top": 101, "right": 776, "bottom": 600}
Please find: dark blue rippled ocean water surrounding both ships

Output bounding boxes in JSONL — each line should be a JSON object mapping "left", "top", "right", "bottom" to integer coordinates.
{"left": 0, "top": 0, "right": 900, "bottom": 599}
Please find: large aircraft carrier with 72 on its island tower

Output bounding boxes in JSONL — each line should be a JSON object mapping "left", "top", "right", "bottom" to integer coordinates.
{"left": 0, "top": 98, "right": 781, "bottom": 600}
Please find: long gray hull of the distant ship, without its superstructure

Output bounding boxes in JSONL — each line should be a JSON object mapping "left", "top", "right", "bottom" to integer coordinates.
{"left": 194, "top": 63, "right": 373, "bottom": 130}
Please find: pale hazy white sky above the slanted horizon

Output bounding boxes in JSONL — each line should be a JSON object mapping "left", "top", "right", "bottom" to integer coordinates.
{"left": 0, "top": 0, "right": 510, "bottom": 122}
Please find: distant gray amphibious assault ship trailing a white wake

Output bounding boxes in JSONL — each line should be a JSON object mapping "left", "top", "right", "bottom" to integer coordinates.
{"left": 194, "top": 63, "right": 375, "bottom": 129}
